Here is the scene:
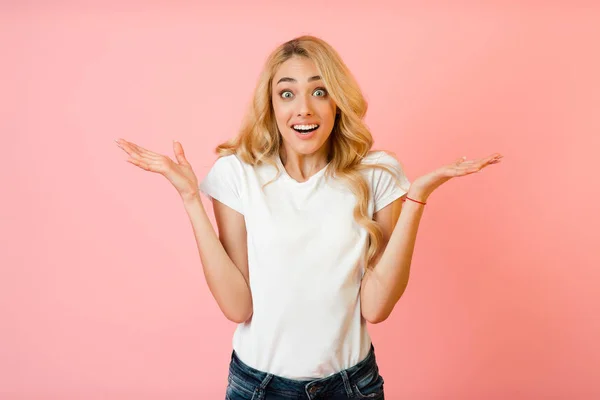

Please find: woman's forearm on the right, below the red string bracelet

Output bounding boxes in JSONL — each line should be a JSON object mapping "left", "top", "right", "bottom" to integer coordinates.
{"left": 361, "top": 194, "right": 424, "bottom": 323}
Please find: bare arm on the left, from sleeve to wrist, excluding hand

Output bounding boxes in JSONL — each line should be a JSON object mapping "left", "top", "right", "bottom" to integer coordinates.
{"left": 182, "top": 191, "right": 253, "bottom": 323}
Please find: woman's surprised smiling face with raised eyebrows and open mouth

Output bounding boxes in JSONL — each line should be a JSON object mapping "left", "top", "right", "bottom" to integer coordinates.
{"left": 272, "top": 56, "right": 337, "bottom": 159}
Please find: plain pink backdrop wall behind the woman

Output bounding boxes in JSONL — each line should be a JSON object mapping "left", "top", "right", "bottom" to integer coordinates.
{"left": 0, "top": 1, "right": 600, "bottom": 400}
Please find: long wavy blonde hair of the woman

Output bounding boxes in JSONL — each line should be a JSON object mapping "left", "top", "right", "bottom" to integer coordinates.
{"left": 215, "top": 35, "right": 406, "bottom": 268}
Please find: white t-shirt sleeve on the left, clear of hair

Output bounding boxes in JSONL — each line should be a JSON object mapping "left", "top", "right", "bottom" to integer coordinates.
{"left": 198, "top": 155, "right": 244, "bottom": 214}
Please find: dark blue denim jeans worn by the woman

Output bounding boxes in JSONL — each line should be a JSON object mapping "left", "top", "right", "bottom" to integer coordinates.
{"left": 225, "top": 345, "right": 384, "bottom": 400}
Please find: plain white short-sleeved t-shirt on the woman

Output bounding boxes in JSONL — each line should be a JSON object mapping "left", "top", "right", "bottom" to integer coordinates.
{"left": 199, "top": 151, "right": 410, "bottom": 380}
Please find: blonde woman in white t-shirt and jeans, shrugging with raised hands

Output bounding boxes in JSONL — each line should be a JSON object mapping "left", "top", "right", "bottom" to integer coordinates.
{"left": 117, "top": 36, "right": 502, "bottom": 400}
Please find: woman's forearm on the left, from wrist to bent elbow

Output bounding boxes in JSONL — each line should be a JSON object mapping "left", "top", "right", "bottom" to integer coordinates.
{"left": 182, "top": 192, "right": 252, "bottom": 323}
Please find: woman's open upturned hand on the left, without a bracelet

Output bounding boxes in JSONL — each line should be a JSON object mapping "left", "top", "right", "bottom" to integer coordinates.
{"left": 115, "top": 139, "right": 198, "bottom": 197}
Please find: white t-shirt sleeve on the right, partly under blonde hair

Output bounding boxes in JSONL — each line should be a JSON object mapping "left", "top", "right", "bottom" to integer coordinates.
{"left": 373, "top": 152, "right": 410, "bottom": 212}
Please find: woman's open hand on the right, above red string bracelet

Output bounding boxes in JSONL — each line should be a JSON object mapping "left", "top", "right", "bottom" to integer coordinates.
{"left": 408, "top": 153, "right": 504, "bottom": 202}
